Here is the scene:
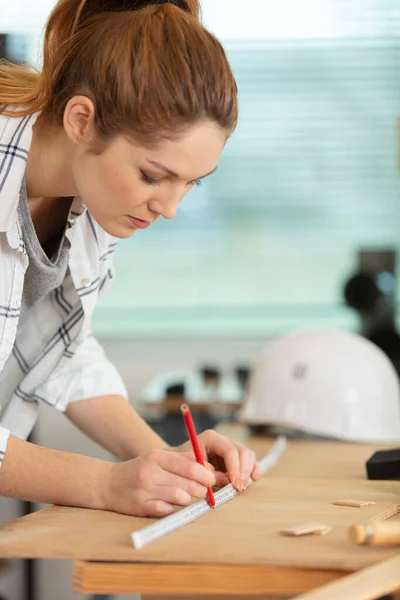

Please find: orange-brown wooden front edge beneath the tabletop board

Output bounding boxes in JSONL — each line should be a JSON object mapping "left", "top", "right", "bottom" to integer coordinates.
{"left": 73, "top": 560, "right": 349, "bottom": 596}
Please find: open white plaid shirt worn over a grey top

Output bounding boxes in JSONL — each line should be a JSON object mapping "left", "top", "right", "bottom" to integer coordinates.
{"left": 0, "top": 109, "right": 127, "bottom": 464}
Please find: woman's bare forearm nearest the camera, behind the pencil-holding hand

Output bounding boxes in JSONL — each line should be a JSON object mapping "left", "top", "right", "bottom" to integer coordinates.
{"left": 0, "top": 435, "right": 113, "bottom": 509}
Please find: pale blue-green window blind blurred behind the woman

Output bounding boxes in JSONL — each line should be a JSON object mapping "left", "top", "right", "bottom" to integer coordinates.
{"left": 0, "top": 0, "right": 400, "bottom": 337}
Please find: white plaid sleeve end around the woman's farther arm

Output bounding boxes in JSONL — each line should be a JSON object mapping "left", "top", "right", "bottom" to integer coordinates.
{"left": 39, "top": 335, "right": 128, "bottom": 412}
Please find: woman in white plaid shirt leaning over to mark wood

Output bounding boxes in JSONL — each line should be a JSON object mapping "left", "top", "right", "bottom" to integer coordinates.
{"left": 0, "top": 0, "right": 259, "bottom": 516}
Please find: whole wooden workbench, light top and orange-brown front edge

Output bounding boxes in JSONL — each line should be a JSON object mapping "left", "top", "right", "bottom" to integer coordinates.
{"left": 0, "top": 426, "right": 400, "bottom": 600}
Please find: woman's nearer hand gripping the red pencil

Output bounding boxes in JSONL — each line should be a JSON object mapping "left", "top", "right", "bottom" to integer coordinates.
{"left": 102, "top": 450, "right": 216, "bottom": 517}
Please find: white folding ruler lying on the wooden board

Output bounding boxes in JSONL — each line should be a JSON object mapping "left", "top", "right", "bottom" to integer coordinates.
{"left": 131, "top": 436, "right": 287, "bottom": 549}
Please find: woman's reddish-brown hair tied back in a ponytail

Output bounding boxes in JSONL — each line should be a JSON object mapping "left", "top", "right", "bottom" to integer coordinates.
{"left": 0, "top": 0, "right": 237, "bottom": 143}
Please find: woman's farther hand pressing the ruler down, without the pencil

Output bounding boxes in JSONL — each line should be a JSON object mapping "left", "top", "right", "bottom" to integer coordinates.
{"left": 175, "top": 430, "right": 261, "bottom": 492}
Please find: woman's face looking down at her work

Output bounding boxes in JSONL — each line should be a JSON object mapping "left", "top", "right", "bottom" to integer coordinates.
{"left": 72, "top": 121, "right": 226, "bottom": 238}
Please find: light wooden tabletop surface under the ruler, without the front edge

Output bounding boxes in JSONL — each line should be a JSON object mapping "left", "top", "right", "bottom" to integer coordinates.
{"left": 0, "top": 476, "right": 400, "bottom": 571}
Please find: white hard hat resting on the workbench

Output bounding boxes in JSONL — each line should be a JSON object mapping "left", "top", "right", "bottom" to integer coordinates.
{"left": 240, "top": 329, "right": 400, "bottom": 442}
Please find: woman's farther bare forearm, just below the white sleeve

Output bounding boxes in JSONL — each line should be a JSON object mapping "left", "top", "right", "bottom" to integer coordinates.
{"left": 66, "top": 396, "right": 168, "bottom": 460}
